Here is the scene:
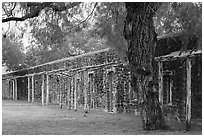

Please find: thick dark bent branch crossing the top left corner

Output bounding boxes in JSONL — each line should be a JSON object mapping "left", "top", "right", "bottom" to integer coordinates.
{"left": 2, "top": 2, "right": 81, "bottom": 23}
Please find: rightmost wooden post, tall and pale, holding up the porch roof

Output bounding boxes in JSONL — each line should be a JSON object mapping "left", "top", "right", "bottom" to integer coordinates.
{"left": 186, "top": 58, "right": 191, "bottom": 131}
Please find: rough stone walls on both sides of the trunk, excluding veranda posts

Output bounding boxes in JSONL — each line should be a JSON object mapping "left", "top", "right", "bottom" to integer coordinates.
{"left": 2, "top": 36, "right": 202, "bottom": 118}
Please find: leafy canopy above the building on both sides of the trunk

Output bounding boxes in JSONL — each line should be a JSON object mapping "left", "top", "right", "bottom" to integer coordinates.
{"left": 2, "top": 2, "right": 202, "bottom": 69}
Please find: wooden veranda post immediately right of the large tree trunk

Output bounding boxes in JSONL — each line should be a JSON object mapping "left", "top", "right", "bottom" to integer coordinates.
{"left": 158, "top": 61, "right": 163, "bottom": 106}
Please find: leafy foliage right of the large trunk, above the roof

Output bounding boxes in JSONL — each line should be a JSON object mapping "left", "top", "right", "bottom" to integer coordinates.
{"left": 154, "top": 2, "right": 202, "bottom": 48}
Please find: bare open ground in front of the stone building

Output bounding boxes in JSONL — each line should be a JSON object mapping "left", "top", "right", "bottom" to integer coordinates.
{"left": 2, "top": 100, "right": 202, "bottom": 135}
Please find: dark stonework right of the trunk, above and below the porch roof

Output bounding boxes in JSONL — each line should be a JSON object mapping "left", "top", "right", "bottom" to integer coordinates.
{"left": 155, "top": 37, "right": 202, "bottom": 119}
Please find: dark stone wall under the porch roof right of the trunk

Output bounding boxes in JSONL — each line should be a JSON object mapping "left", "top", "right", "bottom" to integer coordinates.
{"left": 163, "top": 55, "right": 202, "bottom": 118}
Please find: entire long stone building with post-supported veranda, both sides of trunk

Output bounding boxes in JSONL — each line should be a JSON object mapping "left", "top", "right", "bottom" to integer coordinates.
{"left": 2, "top": 31, "right": 202, "bottom": 129}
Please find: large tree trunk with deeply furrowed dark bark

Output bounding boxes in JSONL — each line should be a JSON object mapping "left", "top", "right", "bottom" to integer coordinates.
{"left": 124, "top": 2, "right": 167, "bottom": 130}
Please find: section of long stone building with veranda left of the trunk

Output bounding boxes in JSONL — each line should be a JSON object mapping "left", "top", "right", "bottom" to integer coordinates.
{"left": 3, "top": 49, "right": 135, "bottom": 112}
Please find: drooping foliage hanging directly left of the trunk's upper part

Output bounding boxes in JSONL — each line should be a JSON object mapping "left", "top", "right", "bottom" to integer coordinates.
{"left": 94, "top": 3, "right": 127, "bottom": 60}
